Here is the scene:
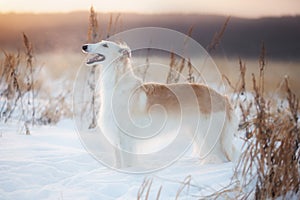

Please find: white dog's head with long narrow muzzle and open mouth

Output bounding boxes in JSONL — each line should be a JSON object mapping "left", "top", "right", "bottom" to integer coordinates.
{"left": 82, "top": 40, "right": 131, "bottom": 65}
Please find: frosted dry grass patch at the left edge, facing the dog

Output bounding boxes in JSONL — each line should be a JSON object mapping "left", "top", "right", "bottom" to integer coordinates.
{"left": 0, "top": 33, "right": 71, "bottom": 131}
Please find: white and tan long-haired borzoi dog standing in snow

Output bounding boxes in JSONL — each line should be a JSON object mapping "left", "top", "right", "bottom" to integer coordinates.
{"left": 82, "top": 41, "right": 238, "bottom": 167}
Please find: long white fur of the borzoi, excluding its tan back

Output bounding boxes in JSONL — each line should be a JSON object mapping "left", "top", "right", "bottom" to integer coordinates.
{"left": 83, "top": 41, "right": 238, "bottom": 167}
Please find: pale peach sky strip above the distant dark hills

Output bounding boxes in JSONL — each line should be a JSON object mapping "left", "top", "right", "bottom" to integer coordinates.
{"left": 0, "top": 0, "right": 300, "bottom": 18}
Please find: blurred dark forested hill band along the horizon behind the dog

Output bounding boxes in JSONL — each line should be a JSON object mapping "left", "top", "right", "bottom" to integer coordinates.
{"left": 0, "top": 12, "right": 300, "bottom": 60}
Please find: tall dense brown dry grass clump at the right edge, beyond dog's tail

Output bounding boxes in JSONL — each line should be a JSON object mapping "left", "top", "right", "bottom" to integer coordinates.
{"left": 223, "top": 44, "right": 300, "bottom": 199}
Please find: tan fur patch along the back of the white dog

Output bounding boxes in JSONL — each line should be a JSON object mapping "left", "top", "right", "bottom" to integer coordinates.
{"left": 141, "top": 83, "right": 231, "bottom": 119}
